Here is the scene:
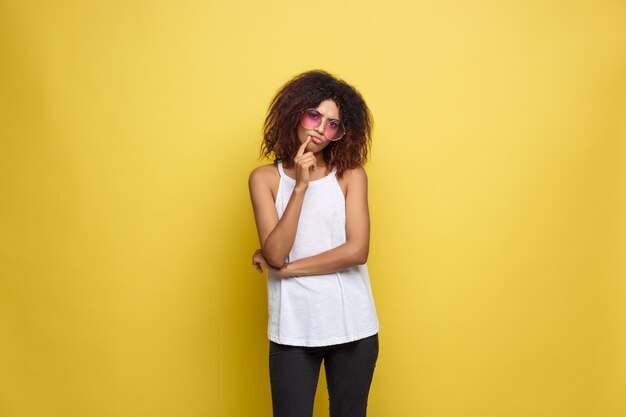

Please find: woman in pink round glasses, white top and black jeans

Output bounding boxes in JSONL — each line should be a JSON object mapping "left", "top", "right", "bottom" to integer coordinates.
{"left": 249, "top": 71, "right": 378, "bottom": 417}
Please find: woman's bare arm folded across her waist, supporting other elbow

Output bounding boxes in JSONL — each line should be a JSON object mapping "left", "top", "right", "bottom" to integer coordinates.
{"left": 262, "top": 167, "right": 370, "bottom": 277}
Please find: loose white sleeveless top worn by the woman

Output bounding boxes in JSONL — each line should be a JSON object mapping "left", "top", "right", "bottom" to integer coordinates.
{"left": 267, "top": 162, "right": 379, "bottom": 346}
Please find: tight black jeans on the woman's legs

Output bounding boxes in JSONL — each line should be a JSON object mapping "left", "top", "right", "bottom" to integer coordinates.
{"left": 270, "top": 334, "right": 378, "bottom": 417}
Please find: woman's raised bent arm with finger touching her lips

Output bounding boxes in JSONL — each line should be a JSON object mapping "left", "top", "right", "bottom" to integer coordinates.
{"left": 248, "top": 139, "right": 315, "bottom": 268}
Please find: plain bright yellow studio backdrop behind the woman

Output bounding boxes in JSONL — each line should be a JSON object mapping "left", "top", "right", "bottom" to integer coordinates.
{"left": 0, "top": 0, "right": 626, "bottom": 417}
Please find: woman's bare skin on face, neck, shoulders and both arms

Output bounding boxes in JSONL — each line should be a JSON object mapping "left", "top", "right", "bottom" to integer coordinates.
{"left": 248, "top": 99, "right": 370, "bottom": 277}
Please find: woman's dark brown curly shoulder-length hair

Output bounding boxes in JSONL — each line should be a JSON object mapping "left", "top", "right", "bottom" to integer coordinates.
{"left": 261, "top": 70, "right": 373, "bottom": 178}
